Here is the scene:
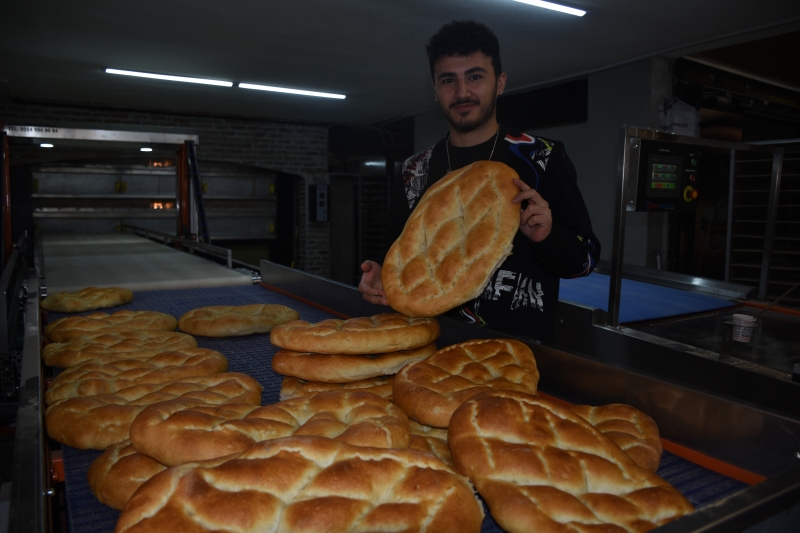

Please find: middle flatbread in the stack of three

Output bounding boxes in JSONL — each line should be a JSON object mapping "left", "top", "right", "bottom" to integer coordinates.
{"left": 272, "top": 344, "right": 436, "bottom": 383}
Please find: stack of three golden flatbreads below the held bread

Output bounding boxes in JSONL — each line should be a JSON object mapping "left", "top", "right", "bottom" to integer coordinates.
{"left": 270, "top": 313, "right": 439, "bottom": 399}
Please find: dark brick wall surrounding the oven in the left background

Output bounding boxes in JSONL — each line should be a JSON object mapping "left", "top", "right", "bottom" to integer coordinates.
{"left": 0, "top": 102, "right": 330, "bottom": 276}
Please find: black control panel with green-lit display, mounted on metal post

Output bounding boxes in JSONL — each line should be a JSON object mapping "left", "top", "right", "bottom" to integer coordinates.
{"left": 631, "top": 139, "right": 702, "bottom": 211}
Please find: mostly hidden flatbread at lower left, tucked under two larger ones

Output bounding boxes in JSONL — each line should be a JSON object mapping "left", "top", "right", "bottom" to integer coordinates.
{"left": 86, "top": 440, "right": 167, "bottom": 510}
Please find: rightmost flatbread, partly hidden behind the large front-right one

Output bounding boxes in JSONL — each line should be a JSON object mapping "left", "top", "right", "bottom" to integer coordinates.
{"left": 570, "top": 403, "right": 662, "bottom": 472}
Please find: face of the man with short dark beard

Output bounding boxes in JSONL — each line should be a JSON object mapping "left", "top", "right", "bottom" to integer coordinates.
{"left": 433, "top": 52, "right": 506, "bottom": 133}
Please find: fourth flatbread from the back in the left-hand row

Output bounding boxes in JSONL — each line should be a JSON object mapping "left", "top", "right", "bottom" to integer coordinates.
{"left": 44, "top": 348, "right": 228, "bottom": 405}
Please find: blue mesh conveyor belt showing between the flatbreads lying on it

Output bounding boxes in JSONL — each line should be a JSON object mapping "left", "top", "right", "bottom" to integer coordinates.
{"left": 49, "top": 286, "right": 747, "bottom": 533}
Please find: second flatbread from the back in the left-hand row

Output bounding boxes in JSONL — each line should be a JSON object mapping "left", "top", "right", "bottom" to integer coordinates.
{"left": 44, "top": 310, "right": 178, "bottom": 342}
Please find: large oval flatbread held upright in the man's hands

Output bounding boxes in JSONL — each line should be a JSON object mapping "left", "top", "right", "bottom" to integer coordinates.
{"left": 381, "top": 161, "right": 520, "bottom": 316}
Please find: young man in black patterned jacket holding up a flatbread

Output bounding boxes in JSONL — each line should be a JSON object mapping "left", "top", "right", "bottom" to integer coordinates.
{"left": 358, "top": 21, "right": 600, "bottom": 341}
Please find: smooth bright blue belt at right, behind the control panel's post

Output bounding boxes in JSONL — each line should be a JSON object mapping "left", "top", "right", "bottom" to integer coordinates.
{"left": 558, "top": 272, "right": 735, "bottom": 323}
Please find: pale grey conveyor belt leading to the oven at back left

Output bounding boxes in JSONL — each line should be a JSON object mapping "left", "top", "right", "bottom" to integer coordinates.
{"left": 42, "top": 233, "right": 253, "bottom": 294}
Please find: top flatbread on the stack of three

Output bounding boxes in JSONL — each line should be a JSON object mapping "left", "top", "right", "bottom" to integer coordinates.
{"left": 269, "top": 313, "right": 439, "bottom": 355}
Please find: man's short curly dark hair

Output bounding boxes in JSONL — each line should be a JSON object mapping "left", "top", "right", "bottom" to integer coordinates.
{"left": 425, "top": 20, "right": 503, "bottom": 78}
